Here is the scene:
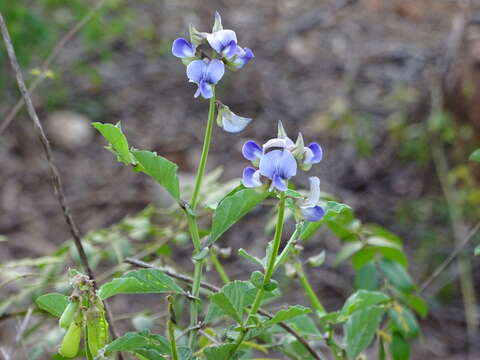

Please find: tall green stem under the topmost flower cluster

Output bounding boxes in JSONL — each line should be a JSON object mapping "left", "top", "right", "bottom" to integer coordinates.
{"left": 187, "top": 88, "right": 215, "bottom": 350}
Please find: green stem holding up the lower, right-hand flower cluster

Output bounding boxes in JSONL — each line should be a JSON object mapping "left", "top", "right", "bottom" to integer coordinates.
{"left": 230, "top": 192, "right": 285, "bottom": 356}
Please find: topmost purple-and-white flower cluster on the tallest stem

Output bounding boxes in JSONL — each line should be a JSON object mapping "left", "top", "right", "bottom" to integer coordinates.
{"left": 172, "top": 12, "right": 253, "bottom": 99}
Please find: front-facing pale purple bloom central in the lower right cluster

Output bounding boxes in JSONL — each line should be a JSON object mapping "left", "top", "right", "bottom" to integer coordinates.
{"left": 260, "top": 150, "right": 297, "bottom": 191}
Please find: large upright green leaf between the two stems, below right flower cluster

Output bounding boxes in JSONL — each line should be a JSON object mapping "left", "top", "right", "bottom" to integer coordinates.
{"left": 208, "top": 189, "right": 269, "bottom": 245}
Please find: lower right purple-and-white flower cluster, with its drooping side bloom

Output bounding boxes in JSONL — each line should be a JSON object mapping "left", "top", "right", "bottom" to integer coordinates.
{"left": 242, "top": 122, "right": 324, "bottom": 221}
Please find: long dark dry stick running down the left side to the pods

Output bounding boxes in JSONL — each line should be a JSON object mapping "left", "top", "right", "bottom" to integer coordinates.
{"left": 0, "top": 12, "right": 122, "bottom": 358}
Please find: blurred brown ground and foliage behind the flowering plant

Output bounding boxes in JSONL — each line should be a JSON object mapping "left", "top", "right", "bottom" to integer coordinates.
{"left": 0, "top": 0, "right": 480, "bottom": 359}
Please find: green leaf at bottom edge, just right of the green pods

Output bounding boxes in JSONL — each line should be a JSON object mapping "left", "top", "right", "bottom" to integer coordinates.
{"left": 104, "top": 331, "right": 170, "bottom": 360}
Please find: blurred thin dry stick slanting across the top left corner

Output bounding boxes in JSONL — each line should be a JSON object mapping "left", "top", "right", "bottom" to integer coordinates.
{"left": 0, "top": 0, "right": 105, "bottom": 136}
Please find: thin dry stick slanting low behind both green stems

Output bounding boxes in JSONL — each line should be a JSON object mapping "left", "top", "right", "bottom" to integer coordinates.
{"left": 124, "top": 258, "right": 322, "bottom": 360}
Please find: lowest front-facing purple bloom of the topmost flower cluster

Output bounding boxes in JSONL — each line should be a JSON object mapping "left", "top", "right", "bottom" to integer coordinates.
{"left": 187, "top": 59, "right": 225, "bottom": 99}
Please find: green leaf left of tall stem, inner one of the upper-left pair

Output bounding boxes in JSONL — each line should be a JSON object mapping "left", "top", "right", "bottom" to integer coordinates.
{"left": 132, "top": 150, "right": 180, "bottom": 200}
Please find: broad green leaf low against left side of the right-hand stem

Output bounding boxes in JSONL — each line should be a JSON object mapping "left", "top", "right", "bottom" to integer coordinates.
{"left": 207, "top": 281, "right": 254, "bottom": 324}
